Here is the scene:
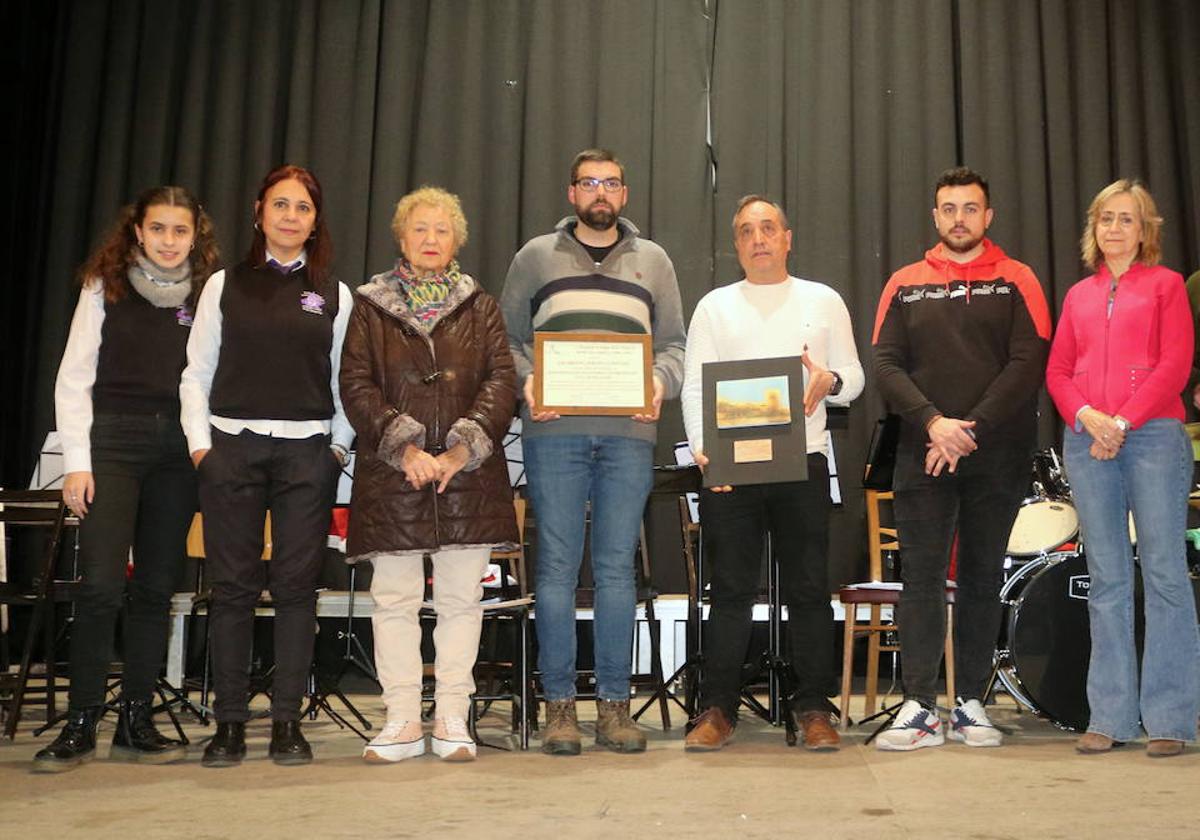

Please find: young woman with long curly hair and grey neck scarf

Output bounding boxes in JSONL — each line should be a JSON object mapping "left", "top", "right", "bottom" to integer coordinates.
{"left": 34, "top": 186, "right": 217, "bottom": 773}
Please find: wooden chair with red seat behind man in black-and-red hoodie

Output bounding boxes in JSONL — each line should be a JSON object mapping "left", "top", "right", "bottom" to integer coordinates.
{"left": 838, "top": 490, "right": 954, "bottom": 730}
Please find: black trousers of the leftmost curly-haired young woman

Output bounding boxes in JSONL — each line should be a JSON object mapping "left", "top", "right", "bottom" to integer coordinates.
{"left": 68, "top": 413, "right": 196, "bottom": 709}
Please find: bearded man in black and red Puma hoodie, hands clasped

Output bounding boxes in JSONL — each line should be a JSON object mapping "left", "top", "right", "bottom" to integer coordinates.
{"left": 874, "top": 167, "right": 1050, "bottom": 750}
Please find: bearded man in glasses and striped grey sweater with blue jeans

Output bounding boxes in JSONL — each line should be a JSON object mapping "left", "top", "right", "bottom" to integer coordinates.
{"left": 500, "top": 149, "right": 685, "bottom": 755}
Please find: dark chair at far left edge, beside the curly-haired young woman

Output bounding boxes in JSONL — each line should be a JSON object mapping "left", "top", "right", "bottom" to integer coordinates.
{"left": 0, "top": 490, "right": 66, "bottom": 739}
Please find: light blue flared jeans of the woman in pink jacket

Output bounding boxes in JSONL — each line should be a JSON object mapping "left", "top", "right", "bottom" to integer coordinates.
{"left": 1063, "top": 419, "right": 1200, "bottom": 740}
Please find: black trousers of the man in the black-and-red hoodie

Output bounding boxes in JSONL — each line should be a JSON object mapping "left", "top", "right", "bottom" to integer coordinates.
{"left": 894, "top": 444, "right": 1031, "bottom": 706}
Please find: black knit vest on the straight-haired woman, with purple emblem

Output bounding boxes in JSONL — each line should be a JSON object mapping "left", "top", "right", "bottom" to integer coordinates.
{"left": 209, "top": 263, "right": 338, "bottom": 420}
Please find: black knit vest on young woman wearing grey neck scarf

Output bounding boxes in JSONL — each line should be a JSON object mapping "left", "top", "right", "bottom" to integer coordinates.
{"left": 91, "top": 289, "right": 192, "bottom": 414}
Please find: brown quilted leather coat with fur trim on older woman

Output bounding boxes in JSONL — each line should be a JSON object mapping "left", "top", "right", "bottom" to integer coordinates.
{"left": 340, "top": 272, "right": 517, "bottom": 560}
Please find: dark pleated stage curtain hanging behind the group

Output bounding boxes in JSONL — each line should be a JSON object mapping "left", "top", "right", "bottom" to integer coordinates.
{"left": 7, "top": 0, "right": 1200, "bottom": 590}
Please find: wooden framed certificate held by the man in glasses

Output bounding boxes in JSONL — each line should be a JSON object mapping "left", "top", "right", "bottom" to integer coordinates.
{"left": 533, "top": 332, "right": 654, "bottom": 416}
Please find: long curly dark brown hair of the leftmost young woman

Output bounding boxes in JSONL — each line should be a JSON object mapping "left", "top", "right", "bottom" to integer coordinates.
{"left": 77, "top": 186, "right": 221, "bottom": 306}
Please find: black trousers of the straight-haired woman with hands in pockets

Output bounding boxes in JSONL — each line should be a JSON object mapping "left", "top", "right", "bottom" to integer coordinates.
{"left": 199, "top": 428, "right": 338, "bottom": 722}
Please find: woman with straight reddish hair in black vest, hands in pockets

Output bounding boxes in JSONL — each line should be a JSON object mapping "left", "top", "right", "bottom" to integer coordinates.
{"left": 180, "top": 166, "right": 354, "bottom": 767}
